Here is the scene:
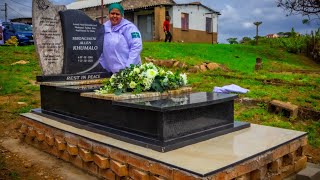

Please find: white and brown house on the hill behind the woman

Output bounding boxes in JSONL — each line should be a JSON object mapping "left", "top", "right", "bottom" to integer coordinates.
{"left": 67, "top": 0, "right": 220, "bottom": 43}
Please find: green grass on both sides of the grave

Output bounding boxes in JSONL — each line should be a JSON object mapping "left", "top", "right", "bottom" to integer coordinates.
{"left": 0, "top": 42, "right": 320, "bottom": 147}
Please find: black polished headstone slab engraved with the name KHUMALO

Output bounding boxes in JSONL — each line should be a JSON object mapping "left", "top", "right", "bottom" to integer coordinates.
{"left": 59, "top": 10, "right": 105, "bottom": 74}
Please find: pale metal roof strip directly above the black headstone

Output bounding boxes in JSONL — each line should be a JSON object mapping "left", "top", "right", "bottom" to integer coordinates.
{"left": 67, "top": 0, "right": 122, "bottom": 9}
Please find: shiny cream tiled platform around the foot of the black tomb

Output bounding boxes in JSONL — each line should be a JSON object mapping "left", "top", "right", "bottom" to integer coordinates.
{"left": 22, "top": 113, "right": 306, "bottom": 176}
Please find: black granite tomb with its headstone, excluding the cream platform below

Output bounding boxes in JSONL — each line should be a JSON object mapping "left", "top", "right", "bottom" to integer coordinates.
{"left": 32, "top": 0, "right": 250, "bottom": 152}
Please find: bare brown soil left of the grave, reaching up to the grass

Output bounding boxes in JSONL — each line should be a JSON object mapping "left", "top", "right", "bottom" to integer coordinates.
{"left": 0, "top": 96, "right": 98, "bottom": 180}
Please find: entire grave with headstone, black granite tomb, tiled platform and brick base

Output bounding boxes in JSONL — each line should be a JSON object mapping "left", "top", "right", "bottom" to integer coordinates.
{"left": 19, "top": 0, "right": 307, "bottom": 179}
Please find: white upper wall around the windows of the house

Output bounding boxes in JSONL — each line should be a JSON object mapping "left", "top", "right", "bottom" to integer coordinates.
{"left": 171, "top": 5, "right": 218, "bottom": 32}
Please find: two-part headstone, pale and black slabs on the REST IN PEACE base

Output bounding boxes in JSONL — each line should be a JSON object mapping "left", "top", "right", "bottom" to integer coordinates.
{"left": 32, "top": 0, "right": 109, "bottom": 82}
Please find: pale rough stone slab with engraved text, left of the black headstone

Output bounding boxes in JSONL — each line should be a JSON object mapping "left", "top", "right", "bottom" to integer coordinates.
{"left": 32, "top": 0, "right": 66, "bottom": 76}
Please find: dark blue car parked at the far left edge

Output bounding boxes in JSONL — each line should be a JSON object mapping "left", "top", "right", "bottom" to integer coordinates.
{"left": 2, "top": 22, "right": 34, "bottom": 45}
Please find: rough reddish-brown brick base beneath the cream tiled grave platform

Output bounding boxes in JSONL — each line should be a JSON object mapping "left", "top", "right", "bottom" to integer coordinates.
{"left": 18, "top": 117, "right": 307, "bottom": 180}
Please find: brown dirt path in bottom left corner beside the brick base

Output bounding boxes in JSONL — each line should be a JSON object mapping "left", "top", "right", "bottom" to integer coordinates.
{"left": 0, "top": 138, "right": 98, "bottom": 180}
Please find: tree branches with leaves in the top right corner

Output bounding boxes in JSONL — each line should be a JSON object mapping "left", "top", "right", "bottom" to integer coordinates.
{"left": 277, "top": 0, "right": 320, "bottom": 23}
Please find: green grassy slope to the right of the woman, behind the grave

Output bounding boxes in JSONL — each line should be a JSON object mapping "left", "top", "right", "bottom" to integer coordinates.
{"left": 142, "top": 43, "right": 320, "bottom": 110}
